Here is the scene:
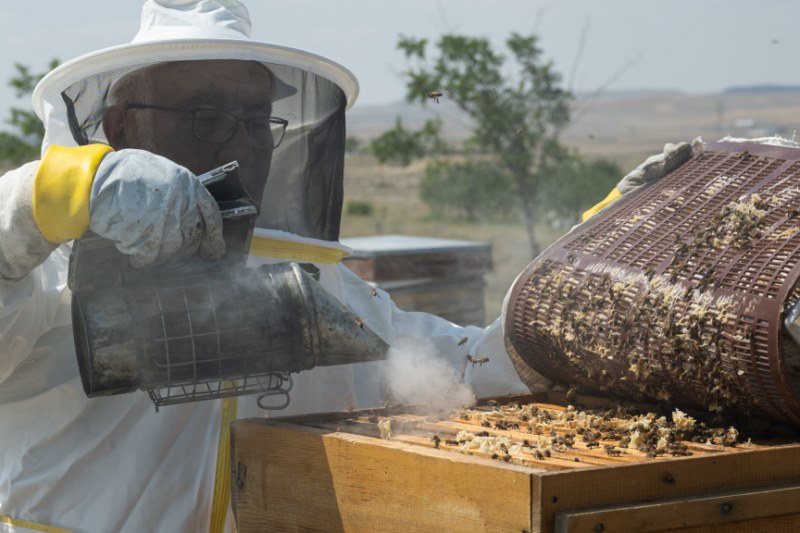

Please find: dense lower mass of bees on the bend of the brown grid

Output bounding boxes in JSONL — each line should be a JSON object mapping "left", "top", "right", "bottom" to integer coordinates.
{"left": 530, "top": 258, "right": 752, "bottom": 413}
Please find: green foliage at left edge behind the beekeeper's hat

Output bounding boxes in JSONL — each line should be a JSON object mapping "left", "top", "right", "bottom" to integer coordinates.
{"left": 0, "top": 59, "right": 59, "bottom": 164}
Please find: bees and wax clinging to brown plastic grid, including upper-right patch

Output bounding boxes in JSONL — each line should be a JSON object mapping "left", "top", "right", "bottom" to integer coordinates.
{"left": 516, "top": 178, "right": 797, "bottom": 413}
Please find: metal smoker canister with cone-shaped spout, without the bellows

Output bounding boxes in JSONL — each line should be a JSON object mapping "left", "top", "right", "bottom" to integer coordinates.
{"left": 72, "top": 263, "right": 389, "bottom": 399}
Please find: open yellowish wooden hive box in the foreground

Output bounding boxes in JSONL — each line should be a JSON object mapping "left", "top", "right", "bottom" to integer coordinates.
{"left": 231, "top": 393, "right": 800, "bottom": 533}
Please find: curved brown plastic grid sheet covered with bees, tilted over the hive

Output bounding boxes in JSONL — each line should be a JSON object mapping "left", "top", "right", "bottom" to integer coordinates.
{"left": 505, "top": 142, "right": 800, "bottom": 425}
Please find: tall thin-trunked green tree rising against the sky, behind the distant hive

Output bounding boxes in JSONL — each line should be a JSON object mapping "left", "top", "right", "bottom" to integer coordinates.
{"left": 398, "top": 33, "right": 572, "bottom": 256}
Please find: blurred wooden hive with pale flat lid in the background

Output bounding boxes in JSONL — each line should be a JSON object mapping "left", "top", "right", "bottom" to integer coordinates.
{"left": 342, "top": 235, "right": 492, "bottom": 326}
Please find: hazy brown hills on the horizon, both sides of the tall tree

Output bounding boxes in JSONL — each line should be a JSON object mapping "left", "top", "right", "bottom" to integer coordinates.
{"left": 347, "top": 85, "right": 800, "bottom": 167}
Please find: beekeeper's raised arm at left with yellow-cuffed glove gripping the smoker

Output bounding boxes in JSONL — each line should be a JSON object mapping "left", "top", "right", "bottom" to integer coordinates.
{"left": 0, "top": 144, "right": 225, "bottom": 281}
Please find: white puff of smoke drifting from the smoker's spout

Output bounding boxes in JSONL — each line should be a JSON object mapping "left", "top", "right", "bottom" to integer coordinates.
{"left": 383, "top": 338, "right": 475, "bottom": 411}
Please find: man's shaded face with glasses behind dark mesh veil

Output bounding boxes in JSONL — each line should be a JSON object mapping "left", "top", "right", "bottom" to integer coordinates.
{"left": 103, "top": 60, "right": 283, "bottom": 203}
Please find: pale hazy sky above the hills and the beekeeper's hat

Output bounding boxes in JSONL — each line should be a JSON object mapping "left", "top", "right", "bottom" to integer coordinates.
{"left": 0, "top": 0, "right": 800, "bottom": 121}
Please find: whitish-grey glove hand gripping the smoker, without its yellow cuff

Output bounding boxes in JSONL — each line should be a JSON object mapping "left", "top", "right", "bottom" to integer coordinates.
{"left": 89, "top": 149, "right": 225, "bottom": 267}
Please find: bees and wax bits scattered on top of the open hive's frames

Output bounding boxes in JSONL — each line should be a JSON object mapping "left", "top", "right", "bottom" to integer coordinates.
{"left": 422, "top": 404, "right": 740, "bottom": 464}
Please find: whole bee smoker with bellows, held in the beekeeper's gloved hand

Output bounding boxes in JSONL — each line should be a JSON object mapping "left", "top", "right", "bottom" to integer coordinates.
{"left": 68, "top": 162, "right": 388, "bottom": 409}
